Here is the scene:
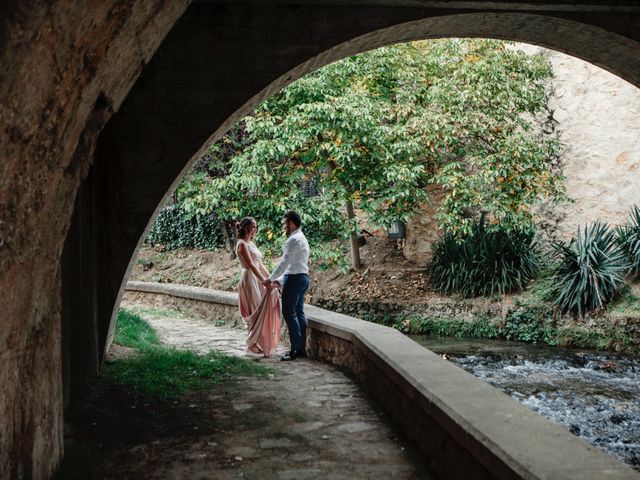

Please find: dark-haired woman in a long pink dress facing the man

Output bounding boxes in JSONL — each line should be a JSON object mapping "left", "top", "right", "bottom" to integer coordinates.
{"left": 236, "top": 217, "right": 280, "bottom": 357}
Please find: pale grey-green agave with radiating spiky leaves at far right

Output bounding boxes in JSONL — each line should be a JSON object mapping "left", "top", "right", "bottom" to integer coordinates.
{"left": 550, "top": 222, "right": 629, "bottom": 317}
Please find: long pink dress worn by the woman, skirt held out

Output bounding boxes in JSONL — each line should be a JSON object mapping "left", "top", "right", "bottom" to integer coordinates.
{"left": 236, "top": 240, "right": 281, "bottom": 357}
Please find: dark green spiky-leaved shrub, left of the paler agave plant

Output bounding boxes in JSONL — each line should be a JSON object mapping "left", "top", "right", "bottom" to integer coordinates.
{"left": 427, "top": 218, "right": 540, "bottom": 298}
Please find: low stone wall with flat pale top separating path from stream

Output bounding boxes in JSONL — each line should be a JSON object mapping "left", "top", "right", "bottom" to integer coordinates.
{"left": 127, "top": 282, "right": 640, "bottom": 480}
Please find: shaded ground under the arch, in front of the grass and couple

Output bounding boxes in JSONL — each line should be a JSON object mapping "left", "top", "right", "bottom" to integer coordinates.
{"left": 57, "top": 348, "right": 430, "bottom": 480}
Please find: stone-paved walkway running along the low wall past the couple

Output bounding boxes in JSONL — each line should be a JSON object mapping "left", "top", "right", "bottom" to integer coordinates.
{"left": 127, "top": 310, "right": 432, "bottom": 480}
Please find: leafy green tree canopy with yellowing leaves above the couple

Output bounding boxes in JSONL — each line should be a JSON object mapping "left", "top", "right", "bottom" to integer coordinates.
{"left": 179, "top": 40, "right": 561, "bottom": 249}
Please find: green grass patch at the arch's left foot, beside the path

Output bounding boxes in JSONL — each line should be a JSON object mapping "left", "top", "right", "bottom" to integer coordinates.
{"left": 104, "top": 310, "right": 271, "bottom": 397}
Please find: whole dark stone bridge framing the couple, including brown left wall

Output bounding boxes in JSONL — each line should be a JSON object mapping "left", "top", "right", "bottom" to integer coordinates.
{"left": 0, "top": 0, "right": 640, "bottom": 478}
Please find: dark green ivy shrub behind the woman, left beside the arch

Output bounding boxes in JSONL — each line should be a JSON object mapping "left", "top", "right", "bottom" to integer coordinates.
{"left": 146, "top": 205, "right": 225, "bottom": 250}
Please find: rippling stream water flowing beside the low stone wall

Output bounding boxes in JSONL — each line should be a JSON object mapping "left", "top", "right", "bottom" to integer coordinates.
{"left": 411, "top": 335, "right": 640, "bottom": 470}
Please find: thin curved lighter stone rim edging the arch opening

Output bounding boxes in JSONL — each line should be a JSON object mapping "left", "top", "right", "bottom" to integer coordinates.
{"left": 90, "top": 12, "right": 640, "bottom": 368}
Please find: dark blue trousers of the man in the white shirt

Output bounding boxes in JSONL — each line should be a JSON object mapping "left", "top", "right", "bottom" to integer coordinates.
{"left": 282, "top": 273, "right": 309, "bottom": 353}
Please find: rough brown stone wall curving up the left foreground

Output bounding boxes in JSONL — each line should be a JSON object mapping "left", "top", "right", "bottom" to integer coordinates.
{"left": 0, "top": 0, "right": 188, "bottom": 479}
